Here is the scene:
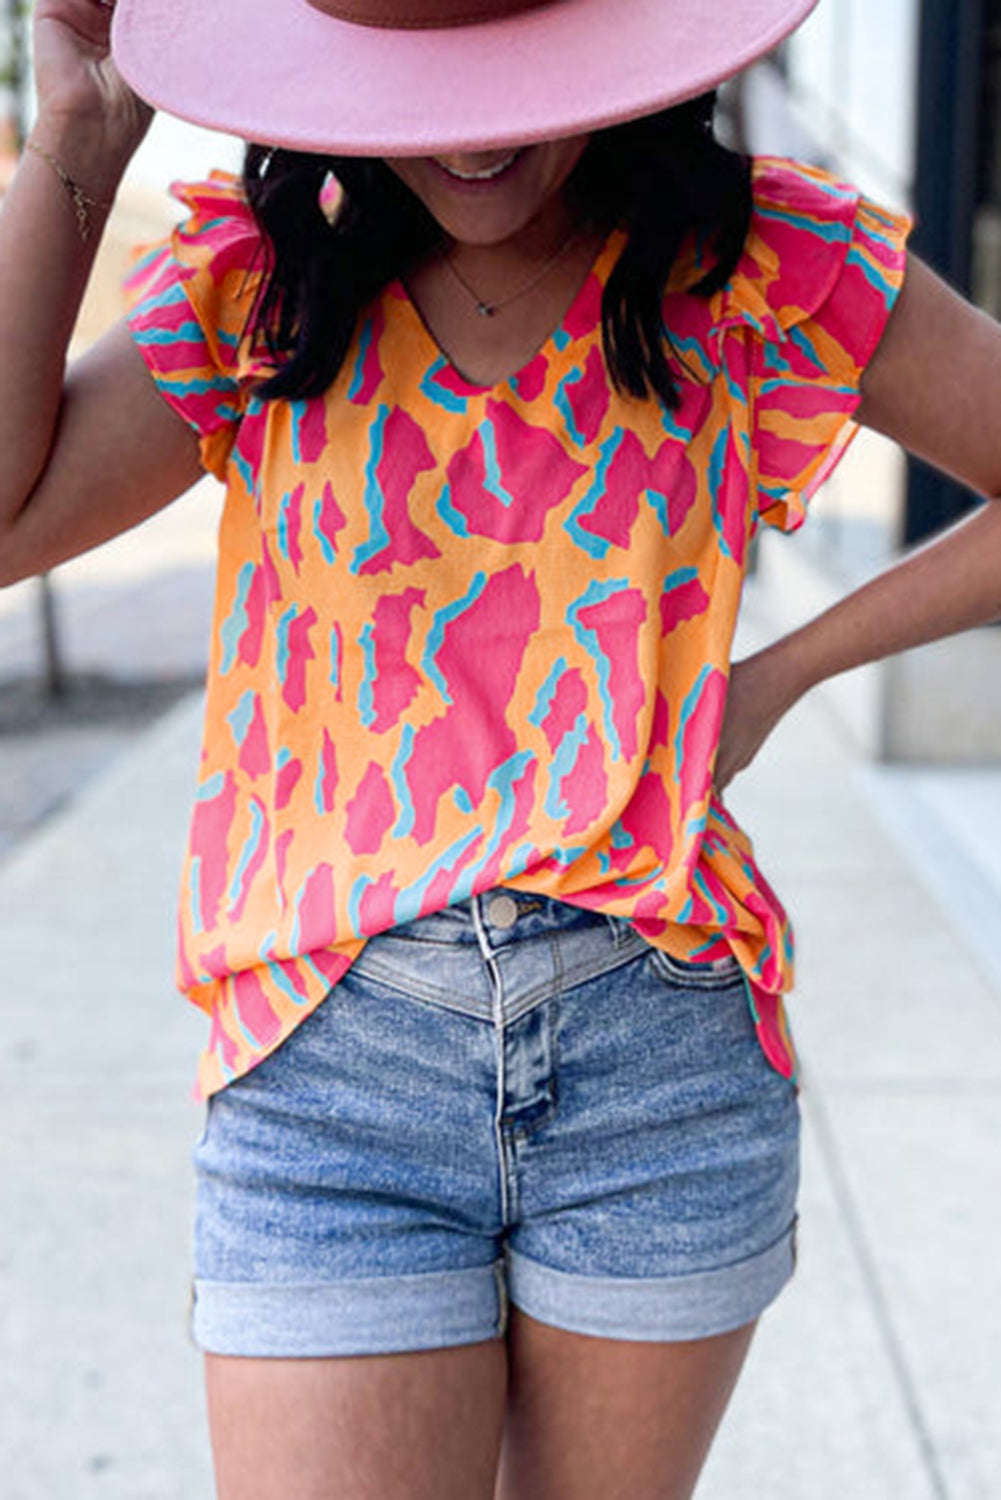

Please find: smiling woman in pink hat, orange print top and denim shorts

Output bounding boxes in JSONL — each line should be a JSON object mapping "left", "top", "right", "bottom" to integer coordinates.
{"left": 0, "top": 0, "right": 1001, "bottom": 1500}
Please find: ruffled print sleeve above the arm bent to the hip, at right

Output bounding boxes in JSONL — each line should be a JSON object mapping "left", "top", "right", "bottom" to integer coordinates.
{"left": 722, "top": 158, "right": 911, "bottom": 531}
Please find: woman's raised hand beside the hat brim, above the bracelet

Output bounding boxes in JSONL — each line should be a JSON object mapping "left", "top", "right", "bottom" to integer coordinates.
{"left": 33, "top": 0, "right": 153, "bottom": 159}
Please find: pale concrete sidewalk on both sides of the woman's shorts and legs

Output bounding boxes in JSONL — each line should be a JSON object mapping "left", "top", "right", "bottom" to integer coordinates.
{"left": 0, "top": 513, "right": 1001, "bottom": 1500}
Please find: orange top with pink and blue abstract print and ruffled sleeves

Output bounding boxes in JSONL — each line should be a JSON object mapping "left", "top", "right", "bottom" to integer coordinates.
{"left": 128, "top": 159, "right": 908, "bottom": 1094}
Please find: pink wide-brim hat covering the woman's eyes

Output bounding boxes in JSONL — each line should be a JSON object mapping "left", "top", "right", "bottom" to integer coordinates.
{"left": 113, "top": 0, "right": 816, "bottom": 156}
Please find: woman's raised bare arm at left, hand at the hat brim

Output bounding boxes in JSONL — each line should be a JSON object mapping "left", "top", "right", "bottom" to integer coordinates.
{"left": 0, "top": 0, "right": 201, "bottom": 584}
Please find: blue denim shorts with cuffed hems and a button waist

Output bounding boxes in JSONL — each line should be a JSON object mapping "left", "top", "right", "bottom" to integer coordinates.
{"left": 192, "top": 890, "right": 800, "bottom": 1358}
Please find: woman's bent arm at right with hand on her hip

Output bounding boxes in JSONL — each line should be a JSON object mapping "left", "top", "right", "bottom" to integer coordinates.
{"left": 716, "top": 257, "right": 1001, "bottom": 791}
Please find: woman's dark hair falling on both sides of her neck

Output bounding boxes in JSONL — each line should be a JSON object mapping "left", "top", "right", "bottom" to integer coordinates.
{"left": 243, "top": 93, "right": 752, "bottom": 408}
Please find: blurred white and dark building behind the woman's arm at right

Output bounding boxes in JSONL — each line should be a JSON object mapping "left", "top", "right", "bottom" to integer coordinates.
{"left": 738, "top": 0, "right": 1001, "bottom": 762}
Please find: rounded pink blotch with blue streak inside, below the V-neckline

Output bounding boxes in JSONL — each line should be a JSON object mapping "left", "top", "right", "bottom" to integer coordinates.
{"left": 449, "top": 401, "right": 587, "bottom": 543}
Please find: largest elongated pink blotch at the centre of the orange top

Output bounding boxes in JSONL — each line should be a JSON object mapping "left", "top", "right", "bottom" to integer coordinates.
{"left": 405, "top": 566, "right": 540, "bottom": 845}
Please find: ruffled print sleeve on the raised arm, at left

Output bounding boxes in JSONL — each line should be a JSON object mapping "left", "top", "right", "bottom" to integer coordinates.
{"left": 125, "top": 173, "right": 266, "bottom": 479}
